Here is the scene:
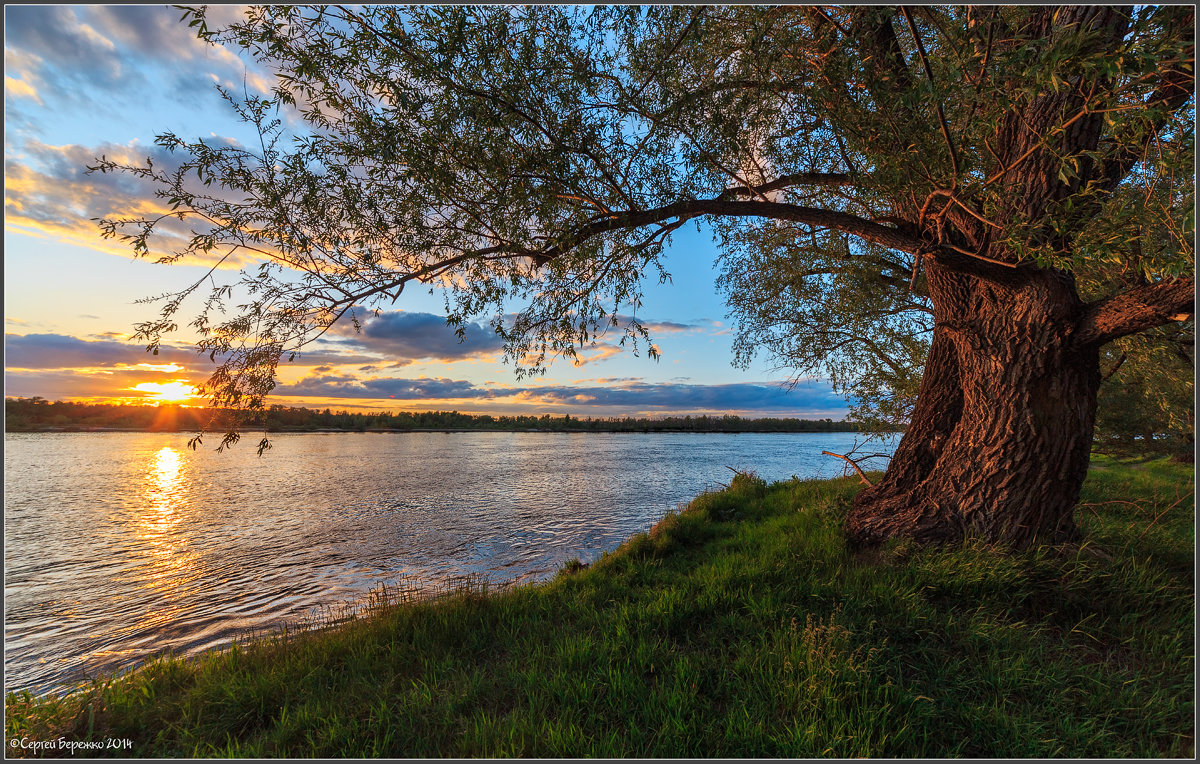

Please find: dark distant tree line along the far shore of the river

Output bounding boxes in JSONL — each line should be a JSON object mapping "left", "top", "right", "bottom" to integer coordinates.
{"left": 5, "top": 397, "right": 878, "bottom": 433}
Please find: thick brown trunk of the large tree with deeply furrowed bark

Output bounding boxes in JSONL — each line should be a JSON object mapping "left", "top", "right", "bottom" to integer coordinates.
{"left": 846, "top": 264, "right": 1100, "bottom": 548}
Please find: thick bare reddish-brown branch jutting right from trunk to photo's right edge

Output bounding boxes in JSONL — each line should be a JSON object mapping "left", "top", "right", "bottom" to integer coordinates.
{"left": 1075, "top": 278, "right": 1195, "bottom": 344}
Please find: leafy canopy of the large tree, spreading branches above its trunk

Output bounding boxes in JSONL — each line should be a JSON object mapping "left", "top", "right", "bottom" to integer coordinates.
{"left": 88, "top": 6, "right": 1194, "bottom": 404}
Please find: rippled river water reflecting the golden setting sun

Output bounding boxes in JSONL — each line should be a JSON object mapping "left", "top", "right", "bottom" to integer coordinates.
{"left": 5, "top": 432, "right": 895, "bottom": 692}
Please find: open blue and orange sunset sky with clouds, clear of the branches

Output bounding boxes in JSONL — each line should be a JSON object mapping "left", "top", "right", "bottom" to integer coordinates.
{"left": 5, "top": 5, "right": 846, "bottom": 420}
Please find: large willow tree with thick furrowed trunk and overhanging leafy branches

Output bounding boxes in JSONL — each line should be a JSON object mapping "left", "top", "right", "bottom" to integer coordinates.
{"left": 96, "top": 6, "right": 1194, "bottom": 546}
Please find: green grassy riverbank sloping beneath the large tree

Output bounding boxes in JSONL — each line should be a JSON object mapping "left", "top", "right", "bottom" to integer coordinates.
{"left": 6, "top": 458, "right": 1195, "bottom": 758}
